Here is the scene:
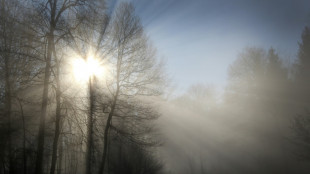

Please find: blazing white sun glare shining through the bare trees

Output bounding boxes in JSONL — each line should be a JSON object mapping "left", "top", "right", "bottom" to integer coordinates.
{"left": 73, "top": 57, "right": 104, "bottom": 81}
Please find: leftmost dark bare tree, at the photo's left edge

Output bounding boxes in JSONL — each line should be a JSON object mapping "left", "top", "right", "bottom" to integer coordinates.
{"left": 0, "top": 0, "right": 39, "bottom": 173}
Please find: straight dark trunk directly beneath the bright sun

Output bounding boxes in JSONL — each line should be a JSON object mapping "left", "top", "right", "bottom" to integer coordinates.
{"left": 85, "top": 77, "right": 95, "bottom": 174}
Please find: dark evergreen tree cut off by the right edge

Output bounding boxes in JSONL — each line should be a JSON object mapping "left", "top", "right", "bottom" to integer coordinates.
{"left": 293, "top": 27, "right": 310, "bottom": 160}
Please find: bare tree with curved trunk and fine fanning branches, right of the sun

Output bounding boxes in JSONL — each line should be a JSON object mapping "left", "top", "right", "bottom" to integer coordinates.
{"left": 99, "top": 3, "right": 163, "bottom": 174}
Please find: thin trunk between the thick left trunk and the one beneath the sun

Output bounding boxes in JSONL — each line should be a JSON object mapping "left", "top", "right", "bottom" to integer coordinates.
{"left": 50, "top": 54, "right": 61, "bottom": 174}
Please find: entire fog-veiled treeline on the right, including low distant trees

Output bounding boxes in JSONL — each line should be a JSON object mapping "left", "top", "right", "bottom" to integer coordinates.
{"left": 170, "top": 27, "right": 310, "bottom": 173}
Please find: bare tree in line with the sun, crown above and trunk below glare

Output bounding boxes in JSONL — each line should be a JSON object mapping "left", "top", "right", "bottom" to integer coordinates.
{"left": 60, "top": 1, "right": 111, "bottom": 173}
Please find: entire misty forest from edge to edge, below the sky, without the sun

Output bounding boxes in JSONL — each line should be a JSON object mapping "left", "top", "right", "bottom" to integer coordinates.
{"left": 0, "top": 0, "right": 310, "bottom": 174}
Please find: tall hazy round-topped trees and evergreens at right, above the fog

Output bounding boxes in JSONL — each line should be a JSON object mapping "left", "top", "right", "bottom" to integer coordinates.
{"left": 226, "top": 27, "right": 310, "bottom": 164}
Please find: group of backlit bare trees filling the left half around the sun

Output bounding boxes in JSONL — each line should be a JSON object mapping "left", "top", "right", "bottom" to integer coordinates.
{"left": 0, "top": 0, "right": 165, "bottom": 174}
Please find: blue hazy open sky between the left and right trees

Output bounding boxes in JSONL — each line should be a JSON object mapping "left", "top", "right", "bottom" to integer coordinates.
{"left": 109, "top": 0, "right": 310, "bottom": 92}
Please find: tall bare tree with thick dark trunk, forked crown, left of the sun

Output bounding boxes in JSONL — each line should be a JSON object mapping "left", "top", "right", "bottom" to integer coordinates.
{"left": 28, "top": 0, "right": 100, "bottom": 174}
